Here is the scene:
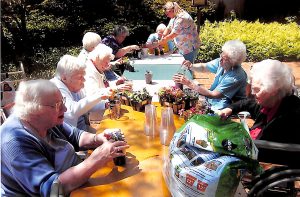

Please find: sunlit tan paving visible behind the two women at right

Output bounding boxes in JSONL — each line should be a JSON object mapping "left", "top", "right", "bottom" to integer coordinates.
{"left": 195, "top": 62, "right": 300, "bottom": 89}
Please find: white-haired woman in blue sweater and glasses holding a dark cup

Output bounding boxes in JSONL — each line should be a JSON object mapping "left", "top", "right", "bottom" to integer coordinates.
{"left": 0, "top": 79, "right": 128, "bottom": 196}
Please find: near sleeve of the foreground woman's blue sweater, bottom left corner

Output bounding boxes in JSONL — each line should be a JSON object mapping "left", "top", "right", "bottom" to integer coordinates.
{"left": 1, "top": 136, "right": 59, "bottom": 196}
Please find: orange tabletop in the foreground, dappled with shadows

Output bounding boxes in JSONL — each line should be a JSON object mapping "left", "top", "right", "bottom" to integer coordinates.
{"left": 70, "top": 103, "right": 184, "bottom": 197}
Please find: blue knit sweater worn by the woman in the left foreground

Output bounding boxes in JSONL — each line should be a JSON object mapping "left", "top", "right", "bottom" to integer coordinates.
{"left": 0, "top": 114, "right": 83, "bottom": 196}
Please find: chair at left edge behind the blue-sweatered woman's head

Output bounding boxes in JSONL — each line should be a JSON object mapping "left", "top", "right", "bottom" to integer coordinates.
{"left": 1, "top": 61, "right": 26, "bottom": 124}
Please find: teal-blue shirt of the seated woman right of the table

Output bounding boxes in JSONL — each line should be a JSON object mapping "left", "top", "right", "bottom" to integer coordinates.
{"left": 206, "top": 58, "right": 247, "bottom": 110}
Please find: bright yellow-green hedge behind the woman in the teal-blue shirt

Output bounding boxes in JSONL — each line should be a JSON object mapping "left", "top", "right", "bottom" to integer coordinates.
{"left": 197, "top": 20, "right": 300, "bottom": 62}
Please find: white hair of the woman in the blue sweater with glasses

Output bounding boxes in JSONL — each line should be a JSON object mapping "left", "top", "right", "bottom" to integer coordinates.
{"left": 13, "top": 79, "right": 59, "bottom": 118}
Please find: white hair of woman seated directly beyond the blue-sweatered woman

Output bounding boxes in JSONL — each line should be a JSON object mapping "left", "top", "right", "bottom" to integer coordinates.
{"left": 55, "top": 55, "right": 85, "bottom": 79}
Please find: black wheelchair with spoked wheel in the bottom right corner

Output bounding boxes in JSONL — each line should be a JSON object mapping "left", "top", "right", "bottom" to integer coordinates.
{"left": 234, "top": 112, "right": 300, "bottom": 197}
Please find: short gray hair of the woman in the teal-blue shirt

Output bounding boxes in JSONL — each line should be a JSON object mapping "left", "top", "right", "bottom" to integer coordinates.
{"left": 222, "top": 40, "right": 247, "bottom": 65}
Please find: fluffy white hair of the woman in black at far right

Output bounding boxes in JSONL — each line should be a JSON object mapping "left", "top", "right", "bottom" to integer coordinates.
{"left": 250, "top": 59, "right": 294, "bottom": 100}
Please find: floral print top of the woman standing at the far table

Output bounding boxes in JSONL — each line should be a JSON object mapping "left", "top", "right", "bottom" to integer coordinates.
{"left": 167, "top": 11, "right": 200, "bottom": 55}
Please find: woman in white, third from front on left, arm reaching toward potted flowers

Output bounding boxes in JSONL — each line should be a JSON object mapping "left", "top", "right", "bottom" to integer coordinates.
{"left": 84, "top": 44, "right": 132, "bottom": 95}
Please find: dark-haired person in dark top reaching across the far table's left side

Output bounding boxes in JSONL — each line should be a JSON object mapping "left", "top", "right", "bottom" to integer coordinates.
{"left": 102, "top": 25, "right": 140, "bottom": 76}
